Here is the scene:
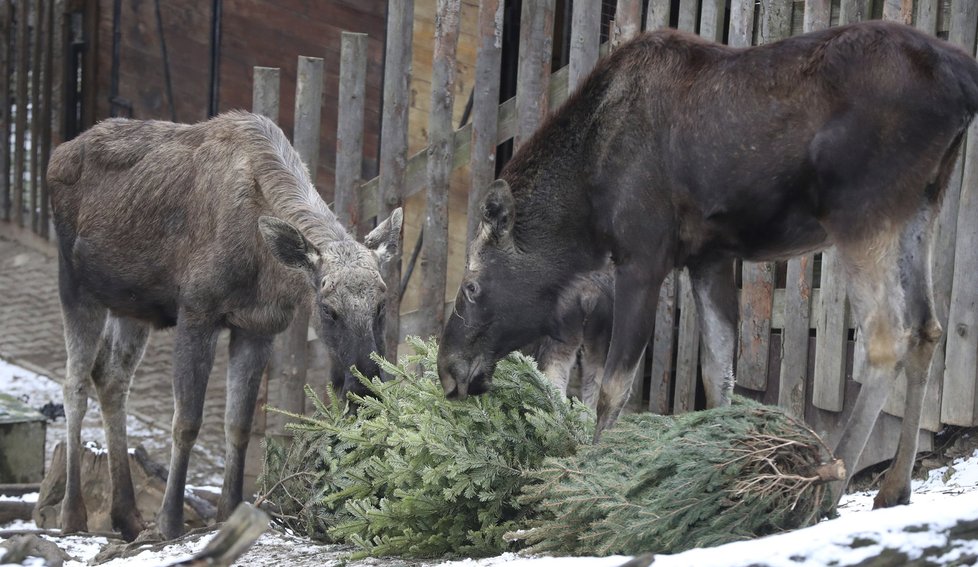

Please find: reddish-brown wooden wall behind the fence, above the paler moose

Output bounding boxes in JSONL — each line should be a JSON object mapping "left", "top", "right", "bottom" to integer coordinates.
{"left": 87, "top": 0, "right": 387, "bottom": 201}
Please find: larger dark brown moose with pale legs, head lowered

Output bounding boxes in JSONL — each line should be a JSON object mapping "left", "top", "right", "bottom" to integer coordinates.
{"left": 438, "top": 21, "right": 978, "bottom": 507}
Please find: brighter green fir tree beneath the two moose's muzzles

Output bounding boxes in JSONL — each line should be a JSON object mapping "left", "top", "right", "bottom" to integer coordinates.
{"left": 259, "top": 338, "right": 593, "bottom": 557}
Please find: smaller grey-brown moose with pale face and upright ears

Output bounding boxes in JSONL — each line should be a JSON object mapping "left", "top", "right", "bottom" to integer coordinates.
{"left": 48, "top": 112, "right": 402, "bottom": 540}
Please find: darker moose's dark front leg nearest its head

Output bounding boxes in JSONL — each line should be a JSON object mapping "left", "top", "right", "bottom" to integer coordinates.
{"left": 594, "top": 260, "right": 668, "bottom": 442}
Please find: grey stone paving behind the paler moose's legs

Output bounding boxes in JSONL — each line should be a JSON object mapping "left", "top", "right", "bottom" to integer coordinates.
{"left": 0, "top": 231, "right": 231, "bottom": 483}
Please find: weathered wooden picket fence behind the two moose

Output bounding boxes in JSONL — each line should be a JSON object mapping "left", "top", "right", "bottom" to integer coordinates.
{"left": 0, "top": 0, "right": 978, "bottom": 470}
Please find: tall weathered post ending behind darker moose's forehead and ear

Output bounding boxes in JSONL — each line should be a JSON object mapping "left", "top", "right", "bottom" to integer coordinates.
{"left": 465, "top": 0, "right": 504, "bottom": 242}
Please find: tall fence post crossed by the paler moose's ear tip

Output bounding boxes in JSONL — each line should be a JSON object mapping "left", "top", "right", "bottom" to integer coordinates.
{"left": 377, "top": 0, "right": 414, "bottom": 360}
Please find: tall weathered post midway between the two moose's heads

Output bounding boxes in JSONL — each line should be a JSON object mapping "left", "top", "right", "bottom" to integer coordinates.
{"left": 420, "top": 0, "right": 462, "bottom": 337}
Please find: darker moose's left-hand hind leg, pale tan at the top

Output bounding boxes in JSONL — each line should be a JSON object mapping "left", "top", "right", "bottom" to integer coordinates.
{"left": 835, "top": 233, "right": 910, "bottom": 501}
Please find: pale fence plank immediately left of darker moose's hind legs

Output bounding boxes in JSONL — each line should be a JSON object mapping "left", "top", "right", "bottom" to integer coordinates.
{"left": 812, "top": 249, "right": 848, "bottom": 411}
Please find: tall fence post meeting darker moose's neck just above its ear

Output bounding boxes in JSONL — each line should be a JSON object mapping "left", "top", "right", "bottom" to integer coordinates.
{"left": 513, "top": 0, "right": 555, "bottom": 148}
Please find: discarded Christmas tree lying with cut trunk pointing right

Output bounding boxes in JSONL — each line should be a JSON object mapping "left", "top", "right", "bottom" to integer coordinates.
{"left": 514, "top": 398, "right": 845, "bottom": 555}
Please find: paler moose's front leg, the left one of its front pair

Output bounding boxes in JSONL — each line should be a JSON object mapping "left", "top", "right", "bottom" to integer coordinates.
{"left": 157, "top": 320, "right": 217, "bottom": 539}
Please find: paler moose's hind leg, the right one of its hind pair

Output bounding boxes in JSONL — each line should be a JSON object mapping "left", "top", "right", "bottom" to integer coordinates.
{"left": 92, "top": 317, "right": 149, "bottom": 541}
